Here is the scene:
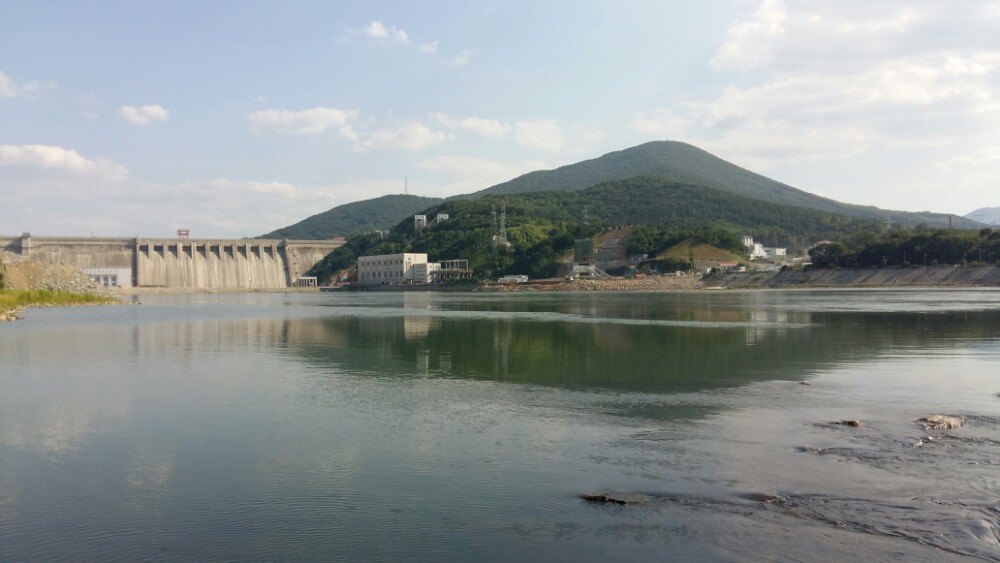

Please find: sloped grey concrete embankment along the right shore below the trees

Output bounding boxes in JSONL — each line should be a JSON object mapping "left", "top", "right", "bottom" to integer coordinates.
{"left": 702, "top": 266, "right": 1000, "bottom": 289}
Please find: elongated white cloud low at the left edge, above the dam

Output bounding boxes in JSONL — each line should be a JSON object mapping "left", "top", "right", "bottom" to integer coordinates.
{"left": 0, "top": 145, "right": 128, "bottom": 181}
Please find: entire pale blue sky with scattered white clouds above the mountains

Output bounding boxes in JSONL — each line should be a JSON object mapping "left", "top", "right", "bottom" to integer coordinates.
{"left": 0, "top": 0, "right": 1000, "bottom": 238}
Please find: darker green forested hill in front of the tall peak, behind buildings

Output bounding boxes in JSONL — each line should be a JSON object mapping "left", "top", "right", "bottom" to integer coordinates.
{"left": 313, "top": 178, "right": 881, "bottom": 280}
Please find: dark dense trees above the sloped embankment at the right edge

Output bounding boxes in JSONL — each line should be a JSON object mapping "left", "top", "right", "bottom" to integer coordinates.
{"left": 809, "top": 228, "right": 1000, "bottom": 268}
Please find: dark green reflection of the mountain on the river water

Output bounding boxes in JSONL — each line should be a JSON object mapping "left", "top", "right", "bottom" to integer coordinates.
{"left": 276, "top": 300, "right": 995, "bottom": 393}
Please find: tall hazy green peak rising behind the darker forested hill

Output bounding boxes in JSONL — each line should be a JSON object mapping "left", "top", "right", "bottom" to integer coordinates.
{"left": 468, "top": 141, "right": 979, "bottom": 228}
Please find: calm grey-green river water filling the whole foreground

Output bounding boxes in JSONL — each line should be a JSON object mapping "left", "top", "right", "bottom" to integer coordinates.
{"left": 0, "top": 290, "right": 1000, "bottom": 560}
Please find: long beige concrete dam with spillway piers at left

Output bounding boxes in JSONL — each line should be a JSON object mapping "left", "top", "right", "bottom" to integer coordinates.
{"left": 0, "top": 234, "right": 345, "bottom": 289}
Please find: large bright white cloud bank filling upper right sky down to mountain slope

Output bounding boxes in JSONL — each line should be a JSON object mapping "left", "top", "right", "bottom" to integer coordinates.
{"left": 629, "top": 0, "right": 1000, "bottom": 210}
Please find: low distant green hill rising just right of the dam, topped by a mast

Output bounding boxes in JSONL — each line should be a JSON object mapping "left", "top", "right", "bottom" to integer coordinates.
{"left": 261, "top": 195, "right": 443, "bottom": 239}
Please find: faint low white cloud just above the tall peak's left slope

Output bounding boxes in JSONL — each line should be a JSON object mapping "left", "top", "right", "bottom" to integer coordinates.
{"left": 419, "top": 155, "right": 547, "bottom": 195}
